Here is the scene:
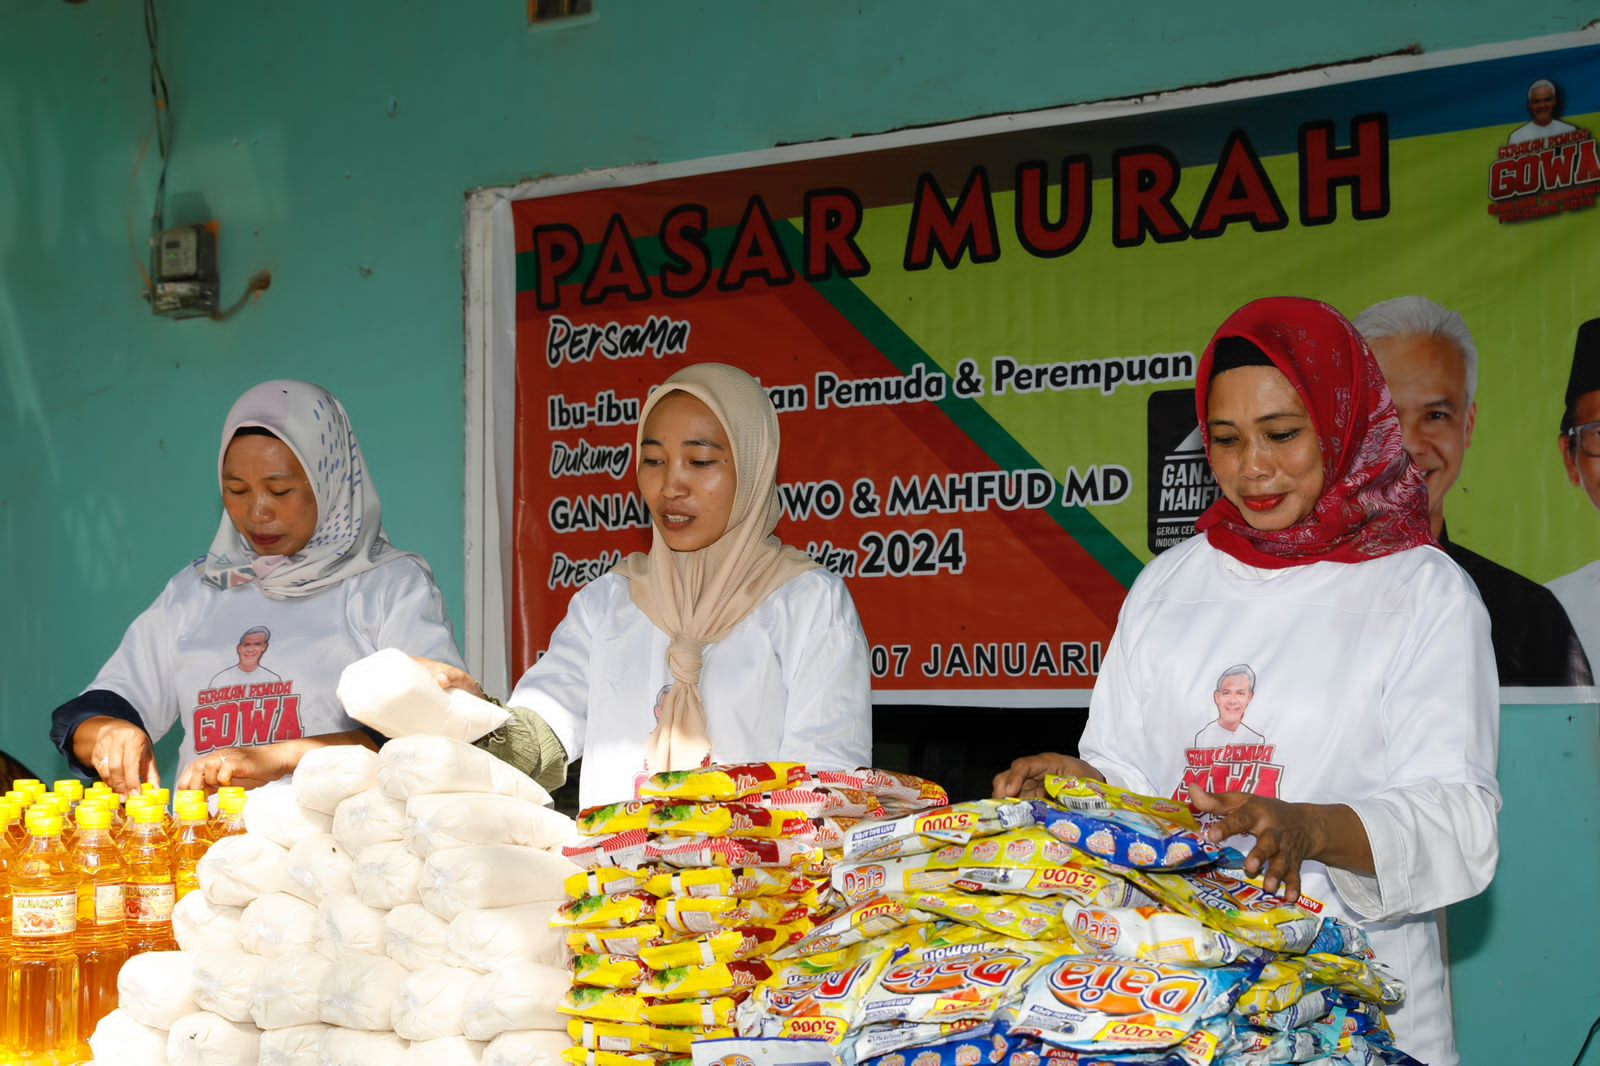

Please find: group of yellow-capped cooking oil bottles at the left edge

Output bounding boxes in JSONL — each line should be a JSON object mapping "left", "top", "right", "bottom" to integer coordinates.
{"left": 0, "top": 779, "right": 232, "bottom": 1063}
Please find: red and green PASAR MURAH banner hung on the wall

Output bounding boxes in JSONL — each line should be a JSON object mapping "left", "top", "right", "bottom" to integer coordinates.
{"left": 512, "top": 35, "right": 1600, "bottom": 706}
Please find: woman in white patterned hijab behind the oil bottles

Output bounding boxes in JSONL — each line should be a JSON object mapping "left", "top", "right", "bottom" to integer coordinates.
{"left": 51, "top": 381, "right": 461, "bottom": 791}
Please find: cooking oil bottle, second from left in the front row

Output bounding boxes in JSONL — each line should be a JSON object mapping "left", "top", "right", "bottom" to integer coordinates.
{"left": 72, "top": 802, "right": 128, "bottom": 1060}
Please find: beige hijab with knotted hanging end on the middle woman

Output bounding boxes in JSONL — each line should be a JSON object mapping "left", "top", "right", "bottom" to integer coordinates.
{"left": 618, "top": 363, "right": 816, "bottom": 773}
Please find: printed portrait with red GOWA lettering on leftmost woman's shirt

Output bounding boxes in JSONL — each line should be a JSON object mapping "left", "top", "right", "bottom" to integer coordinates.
{"left": 194, "top": 626, "right": 304, "bottom": 755}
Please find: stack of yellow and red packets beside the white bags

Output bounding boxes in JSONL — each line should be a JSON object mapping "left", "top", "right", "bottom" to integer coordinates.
{"left": 555, "top": 763, "right": 947, "bottom": 1066}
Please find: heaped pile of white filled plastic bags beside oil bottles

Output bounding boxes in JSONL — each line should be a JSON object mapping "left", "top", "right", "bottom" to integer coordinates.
{"left": 90, "top": 736, "right": 578, "bottom": 1066}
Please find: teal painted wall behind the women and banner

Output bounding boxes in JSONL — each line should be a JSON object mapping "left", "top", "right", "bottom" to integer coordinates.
{"left": 0, "top": 0, "right": 1600, "bottom": 1061}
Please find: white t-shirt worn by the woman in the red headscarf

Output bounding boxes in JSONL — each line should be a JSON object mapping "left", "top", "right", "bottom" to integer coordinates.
{"left": 1080, "top": 535, "right": 1499, "bottom": 1066}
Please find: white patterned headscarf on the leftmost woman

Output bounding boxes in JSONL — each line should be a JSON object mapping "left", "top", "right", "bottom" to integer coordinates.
{"left": 195, "top": 381, "right": 427, "bottom": 600}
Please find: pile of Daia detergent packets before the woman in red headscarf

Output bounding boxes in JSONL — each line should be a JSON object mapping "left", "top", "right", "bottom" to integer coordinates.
{"left": 726, "top": 778, "right": 1413, "bottom": 1066}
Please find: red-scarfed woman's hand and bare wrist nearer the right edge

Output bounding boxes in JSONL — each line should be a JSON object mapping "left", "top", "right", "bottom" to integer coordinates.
{"left": 1189, "top": 784, "right": 1373, "bottom": 903}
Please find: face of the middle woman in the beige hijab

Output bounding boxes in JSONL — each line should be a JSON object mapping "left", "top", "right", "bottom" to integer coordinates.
{"left": 638, "top": 392, "right": 738, "bottom": 552}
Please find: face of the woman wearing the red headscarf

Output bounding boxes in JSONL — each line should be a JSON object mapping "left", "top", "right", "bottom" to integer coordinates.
{"left": 1206, "top": 367, "right": 1323, "bottom": 530}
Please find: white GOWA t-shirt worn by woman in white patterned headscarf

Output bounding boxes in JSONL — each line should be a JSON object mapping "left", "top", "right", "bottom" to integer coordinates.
{"left": 90, "top": 557, "right": 461, "bottom": 765}
